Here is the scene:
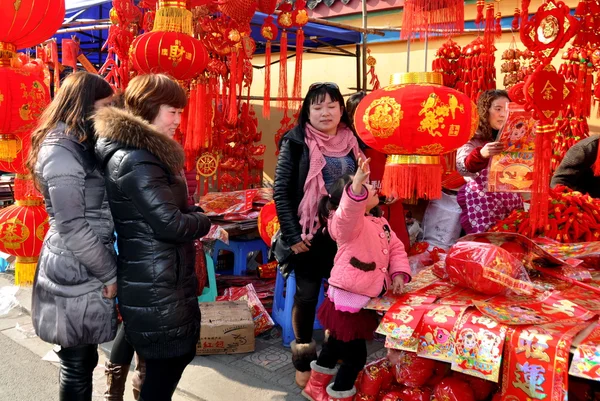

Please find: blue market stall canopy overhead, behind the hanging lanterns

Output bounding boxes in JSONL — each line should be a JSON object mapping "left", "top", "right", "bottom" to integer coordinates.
{"left": 48, "top": 0, "right": 361, "bottom": 65}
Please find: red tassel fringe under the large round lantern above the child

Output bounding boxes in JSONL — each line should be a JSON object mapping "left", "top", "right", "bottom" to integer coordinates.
{"left": 382, "top": 155, "right": 442, "bottom": 199}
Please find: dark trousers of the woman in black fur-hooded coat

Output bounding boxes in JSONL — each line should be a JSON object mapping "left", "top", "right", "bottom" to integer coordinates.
{"left": 138, "top": 351, "right": 196, "bottom": 401}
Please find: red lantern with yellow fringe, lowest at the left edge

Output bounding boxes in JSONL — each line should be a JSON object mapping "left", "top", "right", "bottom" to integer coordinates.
{"left": 0, "top": 198, "right": 49, "bottom": 284}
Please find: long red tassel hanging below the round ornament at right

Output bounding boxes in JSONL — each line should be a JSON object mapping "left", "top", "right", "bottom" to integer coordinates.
{"left": 529, "top": 124, "right": 556, "bottom": 235}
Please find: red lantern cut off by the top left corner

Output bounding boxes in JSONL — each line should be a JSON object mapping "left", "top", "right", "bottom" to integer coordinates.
{"left": 0, "top": 0, "right": 65, "bottom": 58}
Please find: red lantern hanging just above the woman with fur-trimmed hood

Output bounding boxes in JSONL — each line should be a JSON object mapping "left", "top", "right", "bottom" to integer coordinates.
{"left": 131, "top": 31, "right": 208, "bottom": 80}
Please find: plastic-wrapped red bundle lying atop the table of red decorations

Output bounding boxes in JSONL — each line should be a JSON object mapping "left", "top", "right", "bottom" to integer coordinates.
{"left": 446, "top": 241, "right": 528, "bottom": 295}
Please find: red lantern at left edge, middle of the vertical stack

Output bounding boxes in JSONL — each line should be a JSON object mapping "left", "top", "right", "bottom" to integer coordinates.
{"left": 0, "top": 67, "right": 50, "bottom": 174}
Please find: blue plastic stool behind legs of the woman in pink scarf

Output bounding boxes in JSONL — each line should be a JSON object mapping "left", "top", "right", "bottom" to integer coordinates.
{"left": 271, "top": 269, "right": 325, "bottom": 347}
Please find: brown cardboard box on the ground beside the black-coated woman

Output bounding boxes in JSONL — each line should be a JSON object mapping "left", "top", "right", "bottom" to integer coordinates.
{"left": 196, "top": 301, "right": 254, "bottom": 355}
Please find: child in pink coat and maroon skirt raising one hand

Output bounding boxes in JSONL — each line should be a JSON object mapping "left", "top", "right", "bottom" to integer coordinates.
{"left": 302, "top": 159, "right": 410, "bottom": 401}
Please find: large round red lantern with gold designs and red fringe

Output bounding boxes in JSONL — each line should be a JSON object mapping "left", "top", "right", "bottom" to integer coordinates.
{"left": 354, "top": 73, "right": 479, "bottom": 199}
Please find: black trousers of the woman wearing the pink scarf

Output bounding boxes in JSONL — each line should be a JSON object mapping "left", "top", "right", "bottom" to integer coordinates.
{"left": 292, "top": 231, "right": 337, "bottom": 344}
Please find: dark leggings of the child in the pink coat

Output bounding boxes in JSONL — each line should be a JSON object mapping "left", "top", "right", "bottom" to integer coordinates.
{"left": 317, "top": 336, "right": 367, "bottom": 391}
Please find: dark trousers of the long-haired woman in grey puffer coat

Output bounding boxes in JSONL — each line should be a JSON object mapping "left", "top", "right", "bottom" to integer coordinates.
{"left": 56, "top": 345, "right": 98, "bottom": 401}
